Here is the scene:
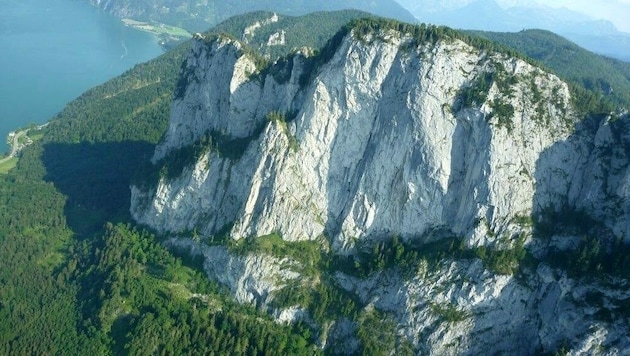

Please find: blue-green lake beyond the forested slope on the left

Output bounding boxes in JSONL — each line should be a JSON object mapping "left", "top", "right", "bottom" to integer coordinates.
{"left": 0, "top": 0, "right": 163, "bottom": 153}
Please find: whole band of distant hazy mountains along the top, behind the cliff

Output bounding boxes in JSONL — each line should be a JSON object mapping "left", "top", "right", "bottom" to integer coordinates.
{"left": 89, "top": 0, "right": 630, "bottom": 61}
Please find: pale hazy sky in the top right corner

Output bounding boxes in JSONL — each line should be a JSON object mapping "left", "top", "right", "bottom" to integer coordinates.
{"left": 537, "top": 0, "right": 630, "bottom": 32}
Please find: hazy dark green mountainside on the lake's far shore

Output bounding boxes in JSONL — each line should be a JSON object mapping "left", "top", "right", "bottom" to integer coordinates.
{"left": 88, "top": 0, "right": 415, "bottom": 32}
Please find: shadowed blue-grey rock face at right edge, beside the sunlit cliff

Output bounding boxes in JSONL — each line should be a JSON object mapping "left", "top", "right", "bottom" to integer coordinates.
{"left": 535, "top": 116, "right": 630, "bottom": 242}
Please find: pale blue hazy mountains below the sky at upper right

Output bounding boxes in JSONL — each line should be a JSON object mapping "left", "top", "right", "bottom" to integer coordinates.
{"left": 399, "top": 0, "right": 630, "bottom": 61}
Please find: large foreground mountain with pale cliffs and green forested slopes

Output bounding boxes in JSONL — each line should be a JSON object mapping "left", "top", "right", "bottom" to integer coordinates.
{"left": 0, "top": 11, "right": 630, "bottom": 354}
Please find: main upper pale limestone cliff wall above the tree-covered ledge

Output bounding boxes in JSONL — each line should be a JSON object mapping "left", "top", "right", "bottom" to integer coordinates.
{"left": 132, "top": 32, "right": 584, "bottom": 250}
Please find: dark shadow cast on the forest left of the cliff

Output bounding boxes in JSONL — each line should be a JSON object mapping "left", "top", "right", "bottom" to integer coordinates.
{"left": 42, "top": 141, "right": 155, "bottom": 237}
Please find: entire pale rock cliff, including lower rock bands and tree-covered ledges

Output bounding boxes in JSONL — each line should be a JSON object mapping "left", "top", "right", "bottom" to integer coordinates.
{"left": 131, "top": 21, "right": 630, "bottom": 354}
